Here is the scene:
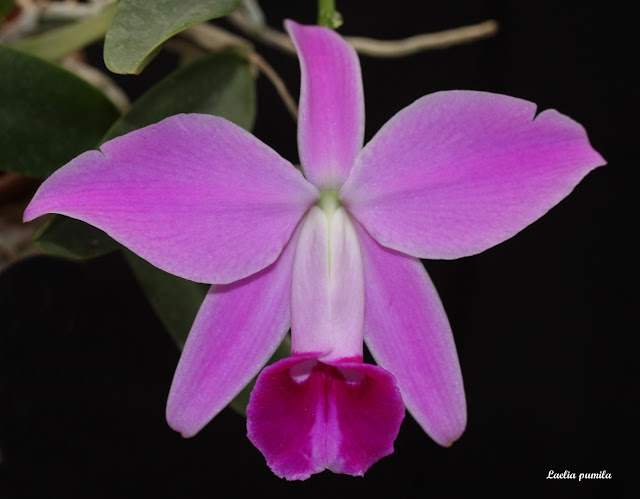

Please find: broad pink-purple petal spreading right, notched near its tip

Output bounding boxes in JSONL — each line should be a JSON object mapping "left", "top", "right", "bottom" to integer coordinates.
{"left": 341, "top": 91, "right": 605, "bottom": 258}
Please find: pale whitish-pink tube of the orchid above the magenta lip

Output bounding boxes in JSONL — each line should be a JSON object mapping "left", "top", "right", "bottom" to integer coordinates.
{"left": 291, "top": 206, "right": 364, "bottom": 362}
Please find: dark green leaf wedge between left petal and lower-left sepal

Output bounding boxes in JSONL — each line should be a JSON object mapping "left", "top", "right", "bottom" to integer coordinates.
{"left": 124, "top": 249, "right": 209, "bottom": 349}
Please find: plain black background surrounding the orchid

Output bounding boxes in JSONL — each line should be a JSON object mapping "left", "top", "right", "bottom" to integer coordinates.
{"left": 0, "top": 0, "right": 640, "bottom": 498}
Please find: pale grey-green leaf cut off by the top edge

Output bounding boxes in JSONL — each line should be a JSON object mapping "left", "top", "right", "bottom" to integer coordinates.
{"left": 104, "top": 0, "right": 240, "bottom": 74}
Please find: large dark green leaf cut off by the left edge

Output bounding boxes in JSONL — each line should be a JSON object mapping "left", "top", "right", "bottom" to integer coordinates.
{"left": 0, "top": 44, "right": 120, "bottom": 178}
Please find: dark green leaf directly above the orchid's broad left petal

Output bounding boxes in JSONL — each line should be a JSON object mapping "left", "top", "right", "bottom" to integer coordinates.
{"left": 103, "top": 50, "right": 256, "bottom": 142}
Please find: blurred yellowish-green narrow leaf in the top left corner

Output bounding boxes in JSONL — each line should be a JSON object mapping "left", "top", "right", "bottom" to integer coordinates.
{"left": 12, "top": 3, "right": 116, "bottom": 61}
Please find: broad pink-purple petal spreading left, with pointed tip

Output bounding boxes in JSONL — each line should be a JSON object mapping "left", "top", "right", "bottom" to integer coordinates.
{"left": 25, "top": 114, "right": 318, "bottom": 283}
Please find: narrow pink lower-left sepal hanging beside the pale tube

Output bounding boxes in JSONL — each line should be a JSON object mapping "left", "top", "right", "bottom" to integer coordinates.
{"left": 167, "top": 223, "right": 299, "bottom": 437}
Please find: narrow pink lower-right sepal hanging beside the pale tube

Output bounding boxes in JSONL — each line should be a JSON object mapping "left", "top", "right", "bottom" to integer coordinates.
{"left": 356, "top": 224, "right": 467, "bottom": 446}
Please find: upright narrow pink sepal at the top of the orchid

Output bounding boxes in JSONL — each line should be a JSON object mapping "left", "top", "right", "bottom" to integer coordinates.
{"left": 285, "top": 21, "right": 364, "bottom": 188}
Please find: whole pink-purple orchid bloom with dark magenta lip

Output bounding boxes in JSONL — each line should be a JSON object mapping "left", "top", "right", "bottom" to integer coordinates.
{"left": 25, "top": 21, "right": 604, "bottom": 479}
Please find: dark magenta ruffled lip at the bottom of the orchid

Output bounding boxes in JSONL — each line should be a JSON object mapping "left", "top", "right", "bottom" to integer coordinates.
{"left": 247, "top": 356, "right": 404, "bottom": 480}
